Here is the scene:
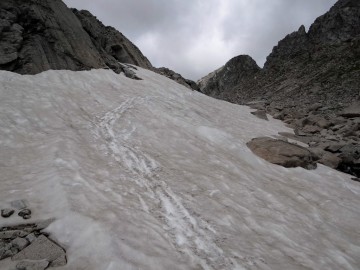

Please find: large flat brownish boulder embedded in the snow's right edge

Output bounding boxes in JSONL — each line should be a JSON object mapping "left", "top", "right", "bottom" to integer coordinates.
{"left": 246, "top": 137, "right": 318, "bottom": 169}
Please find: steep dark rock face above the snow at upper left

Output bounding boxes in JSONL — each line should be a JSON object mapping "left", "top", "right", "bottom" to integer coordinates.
{"left": 0, "top": 0, "right": 151, "bottom": 74}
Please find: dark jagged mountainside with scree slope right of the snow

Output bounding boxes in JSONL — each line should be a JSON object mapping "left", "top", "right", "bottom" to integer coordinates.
{"left": 198, "top": 0, "right": 360, "bottom": 176}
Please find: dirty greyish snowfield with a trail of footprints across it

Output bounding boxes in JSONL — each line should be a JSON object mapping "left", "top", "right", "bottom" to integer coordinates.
{"left": 0, "top": 68, "right": 360, "bottom": 270}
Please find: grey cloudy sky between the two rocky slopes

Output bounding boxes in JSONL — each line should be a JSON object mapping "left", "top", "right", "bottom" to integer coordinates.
{"left": 64, "top": 0, "right": 336, "bottom": 80}
